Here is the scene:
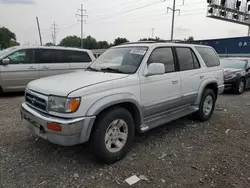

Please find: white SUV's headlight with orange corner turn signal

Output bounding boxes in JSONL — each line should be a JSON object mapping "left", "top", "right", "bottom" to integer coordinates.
{"left": 48, "top": 96, "right": 81, "bottom": 113}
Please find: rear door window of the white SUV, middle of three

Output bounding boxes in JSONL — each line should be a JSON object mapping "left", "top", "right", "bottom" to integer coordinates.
{"left": 176, "top": 47, "right": 200, "bottom": 71}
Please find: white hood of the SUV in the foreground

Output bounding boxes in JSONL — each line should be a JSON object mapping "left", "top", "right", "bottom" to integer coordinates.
{"left": 28, "top": 71, "right": 128, "bottom": 96}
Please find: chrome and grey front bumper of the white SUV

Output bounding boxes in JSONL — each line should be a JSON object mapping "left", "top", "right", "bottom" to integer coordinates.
{"left": 21, "top": 103, "right": 95, "bottom": 146}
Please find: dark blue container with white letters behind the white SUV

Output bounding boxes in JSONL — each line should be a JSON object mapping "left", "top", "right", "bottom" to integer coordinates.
{"left": 190, "top": 37, "right": 250, "bottom": 57}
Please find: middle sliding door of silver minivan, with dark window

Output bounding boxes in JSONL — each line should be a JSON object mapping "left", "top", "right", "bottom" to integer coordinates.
{"left": 36, "top": 49, "right": 71, "bottom": 78}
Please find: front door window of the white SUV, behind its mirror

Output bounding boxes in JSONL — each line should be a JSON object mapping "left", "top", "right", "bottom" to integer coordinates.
{"left": 148, "top": 47, "right": 175, "bottom": 73}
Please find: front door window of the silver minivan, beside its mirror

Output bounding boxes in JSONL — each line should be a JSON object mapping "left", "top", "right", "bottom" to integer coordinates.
{"left": 7, "top": 50, "right": 33, "bottom": 64}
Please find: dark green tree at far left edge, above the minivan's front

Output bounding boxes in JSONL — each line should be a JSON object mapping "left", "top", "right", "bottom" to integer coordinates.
{"left": 0, "top": 27, "right": 20, "bottom": 49}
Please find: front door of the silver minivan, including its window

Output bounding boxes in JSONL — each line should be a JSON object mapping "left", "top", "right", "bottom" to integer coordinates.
{"left": 0, "top": 49, "right": 38, "bottom": 91}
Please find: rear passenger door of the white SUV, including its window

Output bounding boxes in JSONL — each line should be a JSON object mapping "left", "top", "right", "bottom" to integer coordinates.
{"left": 175, "top": 47, "right": 205, "bottom": 105}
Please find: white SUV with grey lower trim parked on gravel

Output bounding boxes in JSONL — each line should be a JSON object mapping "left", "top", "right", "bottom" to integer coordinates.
{"left": 21, "top": 42, "right": 224, "bottom": 163}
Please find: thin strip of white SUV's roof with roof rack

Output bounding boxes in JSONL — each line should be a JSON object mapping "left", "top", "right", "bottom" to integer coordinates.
{"left": 112, "top": 41, "right": 212, "bottom": 48}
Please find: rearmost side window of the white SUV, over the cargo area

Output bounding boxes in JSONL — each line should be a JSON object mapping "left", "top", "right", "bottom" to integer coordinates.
{"left": 196, "top": 47, "right": 220, "bottom": 67}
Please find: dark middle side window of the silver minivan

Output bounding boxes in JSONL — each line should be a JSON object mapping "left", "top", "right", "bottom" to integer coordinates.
{"left": 36, "top": 49, "right": 62, "bottom": 63}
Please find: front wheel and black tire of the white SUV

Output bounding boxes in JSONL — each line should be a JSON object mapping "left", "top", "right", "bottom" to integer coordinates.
{"left": 91, "top": 107, "right": 135, "bottom": 164}
